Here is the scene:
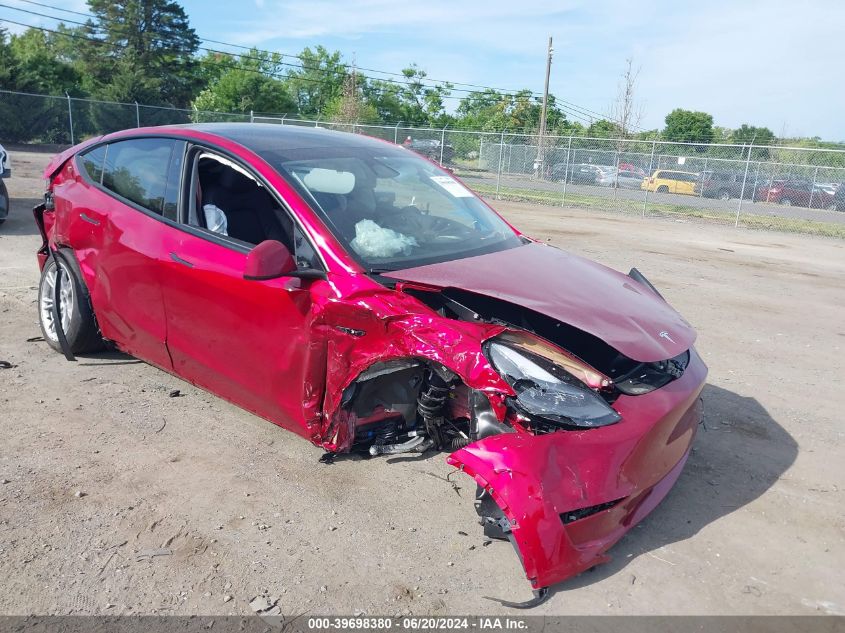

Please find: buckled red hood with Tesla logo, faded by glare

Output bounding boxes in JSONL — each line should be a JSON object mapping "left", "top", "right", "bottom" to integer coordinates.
{"left": 385, "top": 243, "right": 696, "bottom": 362}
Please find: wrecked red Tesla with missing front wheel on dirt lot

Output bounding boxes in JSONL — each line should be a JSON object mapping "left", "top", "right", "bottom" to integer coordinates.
{"left": 34, "top": 124, "right": 707, "bottom": 606}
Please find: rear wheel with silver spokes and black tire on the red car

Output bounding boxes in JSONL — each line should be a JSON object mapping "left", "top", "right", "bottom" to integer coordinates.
{"left": 38, "top": 249, "right": 104, "bottom": 354}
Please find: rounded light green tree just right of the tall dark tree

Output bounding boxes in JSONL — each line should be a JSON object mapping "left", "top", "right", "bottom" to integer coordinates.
{"left": 193, "top": 48, "right": 296, "bottom": 119}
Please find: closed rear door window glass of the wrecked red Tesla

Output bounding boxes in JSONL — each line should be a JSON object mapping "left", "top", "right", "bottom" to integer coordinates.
{"left": 103, "top": 138, "right": 183, "bottom": 214}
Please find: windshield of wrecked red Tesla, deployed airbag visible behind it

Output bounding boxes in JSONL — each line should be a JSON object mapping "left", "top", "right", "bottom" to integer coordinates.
{"left": 265, "top": 144, "right": 522, "bottom": 272}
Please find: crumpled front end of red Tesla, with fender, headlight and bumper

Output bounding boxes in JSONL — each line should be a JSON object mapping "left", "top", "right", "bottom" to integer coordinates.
{"left": 320, "top": 272, "right": 707, "bottom": 606}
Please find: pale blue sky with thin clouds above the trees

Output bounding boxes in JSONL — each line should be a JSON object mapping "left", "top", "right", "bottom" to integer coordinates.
{"left": 0, "top": 0, "right": 845, "bottom": 141}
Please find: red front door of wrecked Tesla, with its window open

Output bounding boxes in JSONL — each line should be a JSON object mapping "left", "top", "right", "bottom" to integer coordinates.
{"left": 157, "top": 148, "right": 329, "bottom": 437}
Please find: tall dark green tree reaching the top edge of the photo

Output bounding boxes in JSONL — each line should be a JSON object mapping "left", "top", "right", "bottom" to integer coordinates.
{"left": 81, "top": 0, "right": 199, "bottom": 108}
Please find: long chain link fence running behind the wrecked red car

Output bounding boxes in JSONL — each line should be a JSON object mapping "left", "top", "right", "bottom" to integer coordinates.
{"left": 0, "top": 90, "right": 845, "bottom": 238}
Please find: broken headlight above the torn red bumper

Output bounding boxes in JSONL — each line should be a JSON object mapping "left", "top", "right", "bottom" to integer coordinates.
{"left": 487, "top": 341, "right": 622, "bottom": 428}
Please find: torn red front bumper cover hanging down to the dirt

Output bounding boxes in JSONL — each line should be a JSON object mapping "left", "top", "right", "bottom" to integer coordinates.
{"left": 448, "top": 349, "right": 707, "bottom": 589}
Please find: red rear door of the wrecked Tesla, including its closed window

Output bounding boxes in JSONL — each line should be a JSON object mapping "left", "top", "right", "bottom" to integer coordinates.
{"left": 70, "top": 138, "right": 185, "bottom": 369}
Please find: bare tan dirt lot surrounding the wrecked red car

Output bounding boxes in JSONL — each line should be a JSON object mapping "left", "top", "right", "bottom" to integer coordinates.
{"left": 0, "top": 148, "right": 845, "bottom": 614}
